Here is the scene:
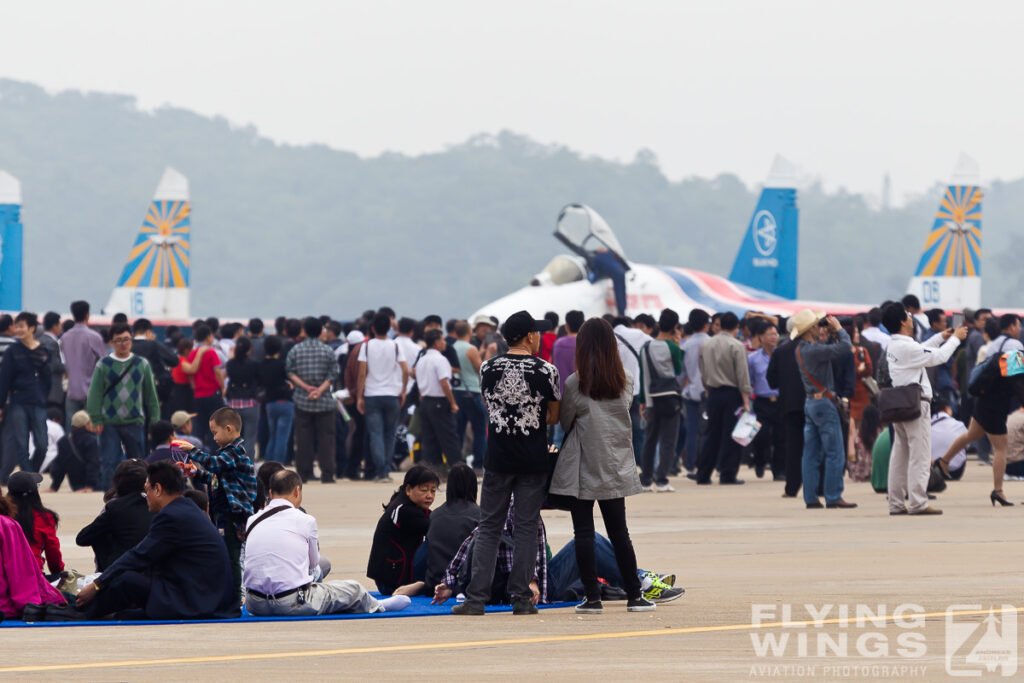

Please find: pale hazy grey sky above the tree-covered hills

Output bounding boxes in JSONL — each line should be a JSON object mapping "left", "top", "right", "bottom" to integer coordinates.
{"left": 0, "top": 0, "right": 1024, "bottom": 199}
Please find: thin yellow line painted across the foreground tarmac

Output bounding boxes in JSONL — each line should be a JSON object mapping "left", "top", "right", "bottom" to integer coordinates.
{"left": 0, "top": 607, "right": 1007, "bottom": 674}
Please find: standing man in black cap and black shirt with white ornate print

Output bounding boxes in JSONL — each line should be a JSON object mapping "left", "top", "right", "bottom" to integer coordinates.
{"left": 452, "top": 310, "right": 561, "bottom": 614}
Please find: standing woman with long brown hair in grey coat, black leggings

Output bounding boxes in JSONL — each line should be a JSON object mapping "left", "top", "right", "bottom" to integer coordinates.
{"left": 551, "top": 317, "right": 654, "bottom": 614}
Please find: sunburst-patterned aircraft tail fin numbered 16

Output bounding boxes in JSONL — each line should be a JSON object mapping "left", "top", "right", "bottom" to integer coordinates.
{"left": 103, "top": 168, "right": 191, "bottom": 319}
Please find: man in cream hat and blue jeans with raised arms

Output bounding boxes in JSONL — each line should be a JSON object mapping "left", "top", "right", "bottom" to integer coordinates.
{"left": 790, "top": 308, "right": 857, "bottom": 509}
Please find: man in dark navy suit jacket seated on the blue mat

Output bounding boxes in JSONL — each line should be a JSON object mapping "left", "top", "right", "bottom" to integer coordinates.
{"left": 52, "top": 461, "right": 241, "bottom": 621}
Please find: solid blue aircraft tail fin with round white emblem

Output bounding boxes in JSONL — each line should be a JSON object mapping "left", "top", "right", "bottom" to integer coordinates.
{"left": 729, "top": 157, "right": 800, "bottom": 299}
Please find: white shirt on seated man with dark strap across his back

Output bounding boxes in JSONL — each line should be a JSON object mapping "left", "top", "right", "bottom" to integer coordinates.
{"left": 242, "top": 498, "right": 319, "bottom": 595}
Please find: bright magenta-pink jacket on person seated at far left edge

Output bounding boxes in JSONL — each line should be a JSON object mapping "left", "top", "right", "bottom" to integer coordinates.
{"left": 0, "top": 515, "right": 65, "bottom": 617}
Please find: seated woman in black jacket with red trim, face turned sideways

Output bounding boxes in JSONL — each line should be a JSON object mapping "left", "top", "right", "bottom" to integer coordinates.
{"left": 367, "top": 465, "right": 440, "bottom": 595}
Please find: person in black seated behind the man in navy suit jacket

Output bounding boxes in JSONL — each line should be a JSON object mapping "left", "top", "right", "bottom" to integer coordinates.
{"left": 75, "top": 459, "right": 153, "bottom": 571}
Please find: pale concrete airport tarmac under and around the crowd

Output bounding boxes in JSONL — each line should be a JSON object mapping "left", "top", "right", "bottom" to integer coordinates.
{"left": 0, "top": 462, "right": 1024, "bottom": 682}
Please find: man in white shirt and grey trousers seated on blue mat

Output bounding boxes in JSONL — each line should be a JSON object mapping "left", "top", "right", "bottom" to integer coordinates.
{"left": 242, "top": 470, "right": 411, "bottom": 616}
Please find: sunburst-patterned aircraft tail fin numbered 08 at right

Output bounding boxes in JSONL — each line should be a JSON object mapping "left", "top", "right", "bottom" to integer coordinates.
{"left": 907, "top": 154, "right": 982, "bottom": 310}
